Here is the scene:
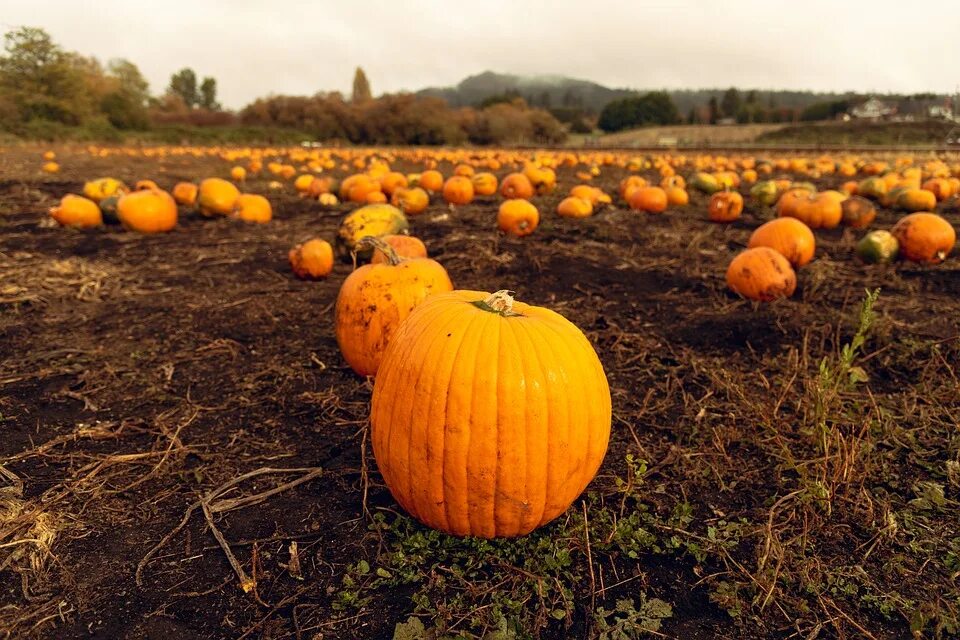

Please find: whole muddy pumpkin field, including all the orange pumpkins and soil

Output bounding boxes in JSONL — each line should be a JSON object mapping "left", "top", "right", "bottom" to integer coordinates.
{"left": 0, "top": 143, "right": 960, "bottom": 640}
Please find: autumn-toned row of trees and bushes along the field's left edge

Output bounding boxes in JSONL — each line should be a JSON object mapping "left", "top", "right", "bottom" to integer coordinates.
{"left": 0, "top": 27, "right": 566, "bottom": 145}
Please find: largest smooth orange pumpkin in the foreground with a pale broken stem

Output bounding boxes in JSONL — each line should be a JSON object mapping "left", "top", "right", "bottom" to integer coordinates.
{"left": 370, "top": 291, "right": 611, "bottom": 538}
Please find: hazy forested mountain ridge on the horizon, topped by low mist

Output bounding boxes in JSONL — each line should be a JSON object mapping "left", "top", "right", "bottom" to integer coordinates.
{"left": 417, "top": 71, "right": 939, "bottom": 116}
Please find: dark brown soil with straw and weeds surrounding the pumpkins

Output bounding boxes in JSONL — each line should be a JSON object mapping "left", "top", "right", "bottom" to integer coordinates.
{"left": 0, "top": 148, "right": 960, "bottom": 639}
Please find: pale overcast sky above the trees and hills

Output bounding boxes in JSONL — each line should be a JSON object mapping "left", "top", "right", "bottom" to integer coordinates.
{"left": 0, "top": 0, "right": 960, "bottom": 108}
